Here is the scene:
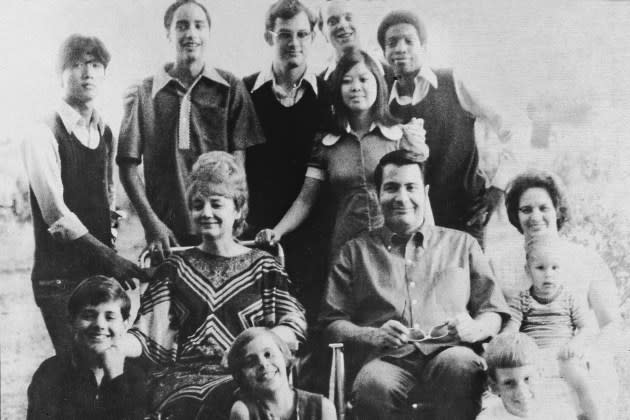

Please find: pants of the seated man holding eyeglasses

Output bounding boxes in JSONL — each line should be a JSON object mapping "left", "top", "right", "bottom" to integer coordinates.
{"left": 352, "top": 346, "right": 485, "bottom": 420}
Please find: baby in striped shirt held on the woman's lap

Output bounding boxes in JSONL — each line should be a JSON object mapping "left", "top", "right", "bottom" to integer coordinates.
{"left": 505, "top": 235, "right": 603, "bottom": 420}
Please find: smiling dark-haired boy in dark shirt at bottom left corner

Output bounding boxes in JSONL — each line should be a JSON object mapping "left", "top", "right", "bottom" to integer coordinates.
{"left": 27, "top": 276, "right": 146, "bottom": 420}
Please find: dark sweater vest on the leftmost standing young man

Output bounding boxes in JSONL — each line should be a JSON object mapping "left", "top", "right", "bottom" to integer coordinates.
{"left": 31, "top": 114, "right": 112, "bottom": 282}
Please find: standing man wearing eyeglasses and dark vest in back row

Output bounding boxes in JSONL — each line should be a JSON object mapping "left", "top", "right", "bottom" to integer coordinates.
{"left": 244, "top": 0, "right": 331, "bottom": 324}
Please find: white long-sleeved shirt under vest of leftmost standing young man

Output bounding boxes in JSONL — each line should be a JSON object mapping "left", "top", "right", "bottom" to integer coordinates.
{"left": 22, "top": 101, "right": 115, "bottom": 241}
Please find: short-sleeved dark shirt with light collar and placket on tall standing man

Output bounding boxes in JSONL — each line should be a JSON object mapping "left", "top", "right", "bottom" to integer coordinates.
{"left": 116, "top": 64, "right": 264, "bottom": 241}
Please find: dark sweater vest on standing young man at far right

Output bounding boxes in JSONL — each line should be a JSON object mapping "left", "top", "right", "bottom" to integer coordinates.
{"left": 390, "top": 70, "right": 485, "bottom": 229}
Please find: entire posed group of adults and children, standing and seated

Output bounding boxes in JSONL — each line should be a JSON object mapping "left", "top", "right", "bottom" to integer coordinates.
{"left": 23, "top": 0, "right": 619, "bottom": 420}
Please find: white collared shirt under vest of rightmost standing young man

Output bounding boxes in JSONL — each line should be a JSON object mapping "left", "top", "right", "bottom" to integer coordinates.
{"left": 389, "top": 66, "right": 529, "bottom": 190}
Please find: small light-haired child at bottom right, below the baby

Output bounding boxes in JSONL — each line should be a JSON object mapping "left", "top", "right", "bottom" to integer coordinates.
{"left": 484, "top": 332, "right": 577, "bottom": 420}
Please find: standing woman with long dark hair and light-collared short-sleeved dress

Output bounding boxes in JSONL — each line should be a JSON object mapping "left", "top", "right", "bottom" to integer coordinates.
{"left": 257, "top": 50, "right": 428, "bottom": 258}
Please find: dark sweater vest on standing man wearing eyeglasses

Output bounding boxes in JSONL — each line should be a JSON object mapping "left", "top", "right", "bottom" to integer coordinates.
{"left": 243, "top": 73, "right": 332, "bottom": 228}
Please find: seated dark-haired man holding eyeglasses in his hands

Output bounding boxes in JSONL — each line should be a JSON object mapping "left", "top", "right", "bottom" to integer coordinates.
{"left": 320, "top": 150, "right": 508, "bottom": 420}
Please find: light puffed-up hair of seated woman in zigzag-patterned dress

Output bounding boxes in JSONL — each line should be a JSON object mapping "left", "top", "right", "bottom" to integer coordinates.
{"left": 186, "top": 151, "right": 248, "bottom": 236}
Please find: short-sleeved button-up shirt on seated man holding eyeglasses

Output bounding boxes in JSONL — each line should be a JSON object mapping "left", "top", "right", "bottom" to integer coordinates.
{"left": 320, "top": 223, "right": 509, "bottom": 354}
